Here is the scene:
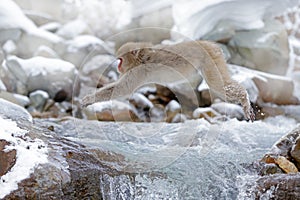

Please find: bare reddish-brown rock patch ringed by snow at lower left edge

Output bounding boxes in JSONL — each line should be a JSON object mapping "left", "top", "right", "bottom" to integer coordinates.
{"left": 0, "top": 140, "right": 16, "bottom": 177}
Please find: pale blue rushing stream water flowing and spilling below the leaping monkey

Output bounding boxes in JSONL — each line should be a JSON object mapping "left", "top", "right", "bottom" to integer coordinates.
{"left": 56, "top": 117, "right": 296, "bottom": 199}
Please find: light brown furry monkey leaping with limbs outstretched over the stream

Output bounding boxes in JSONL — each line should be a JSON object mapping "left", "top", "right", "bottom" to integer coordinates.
{"left": 82, "top": 41, "right": 255, "bottom": 121}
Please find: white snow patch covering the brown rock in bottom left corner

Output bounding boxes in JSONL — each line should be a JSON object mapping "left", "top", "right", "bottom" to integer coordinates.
{"left": 0, "top": 116, "right": 48, "bottom": 198}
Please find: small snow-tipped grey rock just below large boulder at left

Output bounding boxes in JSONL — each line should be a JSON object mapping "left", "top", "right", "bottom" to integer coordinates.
{"left": 29, "top": 90, "right": 49, "bottom": 112}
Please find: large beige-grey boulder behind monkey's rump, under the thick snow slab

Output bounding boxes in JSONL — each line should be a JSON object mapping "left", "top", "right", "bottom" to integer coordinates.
{"left": 229, "top": 20, "right": 289, "bottom": 75}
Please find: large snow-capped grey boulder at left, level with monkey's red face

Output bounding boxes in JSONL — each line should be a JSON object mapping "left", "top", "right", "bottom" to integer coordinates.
{"left": 4, "top": 56, "right": 78, "bottom": 99}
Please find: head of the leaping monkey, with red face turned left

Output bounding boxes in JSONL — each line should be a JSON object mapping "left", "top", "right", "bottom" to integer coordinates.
{"left": 116, "top": 42, "right": 153, "bottom": 74}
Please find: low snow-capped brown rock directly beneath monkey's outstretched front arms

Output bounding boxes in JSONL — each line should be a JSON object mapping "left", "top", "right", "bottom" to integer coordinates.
{"left": 84, "top": 100, "right": 140, "bottom": 121}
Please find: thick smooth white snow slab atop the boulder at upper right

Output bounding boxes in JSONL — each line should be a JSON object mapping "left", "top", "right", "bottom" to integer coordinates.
{"left": 173, "top": 0, "right": 298, "bottom": 39}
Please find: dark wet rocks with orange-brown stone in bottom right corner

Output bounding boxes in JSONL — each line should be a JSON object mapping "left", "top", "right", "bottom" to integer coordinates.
{"left": 240, "top": 126, "right": 300, "bottom": 200}
